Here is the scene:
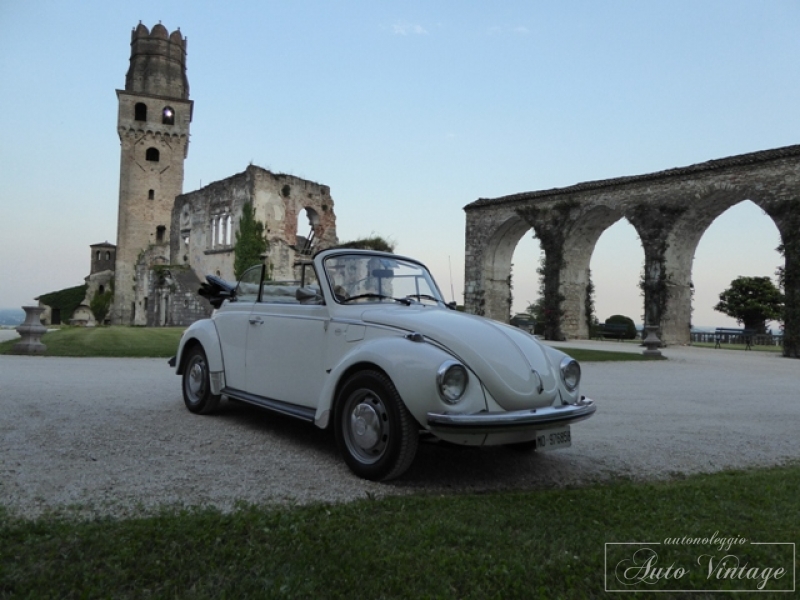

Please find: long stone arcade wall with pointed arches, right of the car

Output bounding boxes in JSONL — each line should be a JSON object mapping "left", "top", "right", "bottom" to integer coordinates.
{"left": 464, "top": 146, "right": 800, "bottom": 356}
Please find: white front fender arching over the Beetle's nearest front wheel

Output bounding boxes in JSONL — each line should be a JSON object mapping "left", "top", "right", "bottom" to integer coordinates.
{"left": 314, "top": 336, "right": 486, "bottom": 428}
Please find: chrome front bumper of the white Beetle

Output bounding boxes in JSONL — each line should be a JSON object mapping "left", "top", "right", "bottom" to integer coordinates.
{"left": 428, "top": 398, "right": 597, "bottom": 433}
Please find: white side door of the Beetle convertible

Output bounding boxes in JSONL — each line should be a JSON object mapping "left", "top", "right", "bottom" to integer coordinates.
{"left": 246, "top": 282, "right": 329, "bottom": 408}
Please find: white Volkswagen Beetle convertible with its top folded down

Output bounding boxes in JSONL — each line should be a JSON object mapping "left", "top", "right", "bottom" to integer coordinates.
{"left": 170, "top": 249, "right": 595, "bottom": 480}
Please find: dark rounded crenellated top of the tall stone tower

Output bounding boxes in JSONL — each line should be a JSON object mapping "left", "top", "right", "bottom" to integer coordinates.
{"left": 125, "top": 21, "right": 189, "bottom": 100}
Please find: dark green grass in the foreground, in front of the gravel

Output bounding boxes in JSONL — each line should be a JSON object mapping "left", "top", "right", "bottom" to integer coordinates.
{"left": 0, "top": 465, "right": 800, "bottom": 600}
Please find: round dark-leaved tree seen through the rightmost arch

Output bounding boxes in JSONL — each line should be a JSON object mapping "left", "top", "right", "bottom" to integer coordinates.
{"left": 714, "top": 277, "right": 783, "bottom": 333}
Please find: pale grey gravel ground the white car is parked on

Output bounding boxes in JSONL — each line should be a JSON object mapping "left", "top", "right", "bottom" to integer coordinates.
{"left": 0, "top": 342, "right": 800, "bottom": 517}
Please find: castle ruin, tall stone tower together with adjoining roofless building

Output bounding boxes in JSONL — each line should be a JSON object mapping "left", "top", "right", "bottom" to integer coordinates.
{"left": 108, "top": 23, "right": 336, "bottom": 326}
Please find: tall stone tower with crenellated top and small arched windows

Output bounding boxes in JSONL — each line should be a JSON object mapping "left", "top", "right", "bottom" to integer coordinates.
{"left": 112, "top": 23, "right": 193, "bottom": 325}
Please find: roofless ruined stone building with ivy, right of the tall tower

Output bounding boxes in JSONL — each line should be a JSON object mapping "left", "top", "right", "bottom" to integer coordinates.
{"left": 170, "top": 165, "right": 337, "bottom": 280}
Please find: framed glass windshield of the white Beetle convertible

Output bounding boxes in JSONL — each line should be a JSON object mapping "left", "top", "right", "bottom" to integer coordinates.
{"left": 325, "top": 254, "right": 444, "bottom": 304}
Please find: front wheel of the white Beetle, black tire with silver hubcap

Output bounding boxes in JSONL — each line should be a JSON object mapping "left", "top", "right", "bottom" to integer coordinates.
{"left": 334, "top": 371, "right": 419, "bottom": 481}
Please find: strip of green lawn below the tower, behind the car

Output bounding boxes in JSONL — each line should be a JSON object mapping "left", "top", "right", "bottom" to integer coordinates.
{"left": 0, "top": 327, "right": 185, "bottom": 358}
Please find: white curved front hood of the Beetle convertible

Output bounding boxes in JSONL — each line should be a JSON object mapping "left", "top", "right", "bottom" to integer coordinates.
{"left": 362, "top": 306, "right": 558, "bottom": 410}
